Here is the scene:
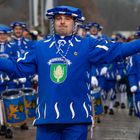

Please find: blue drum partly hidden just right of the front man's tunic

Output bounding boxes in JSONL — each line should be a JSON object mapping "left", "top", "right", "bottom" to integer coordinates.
{"left": 91, "top": 88, "right": 104, "bottom": 116}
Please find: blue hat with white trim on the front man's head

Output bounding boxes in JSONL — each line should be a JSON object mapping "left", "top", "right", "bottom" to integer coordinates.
{"left": 46, "top": 6, "right": 85, "bottom": 22}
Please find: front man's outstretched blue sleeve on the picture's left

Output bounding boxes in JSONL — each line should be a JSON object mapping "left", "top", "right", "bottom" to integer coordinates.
{"left": 0, "top": 46, "right": 37, "bottom": 77}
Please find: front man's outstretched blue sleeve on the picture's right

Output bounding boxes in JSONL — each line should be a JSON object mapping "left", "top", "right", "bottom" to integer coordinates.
{"left": 89, "top": 39, "right": 140, "bottom": 64}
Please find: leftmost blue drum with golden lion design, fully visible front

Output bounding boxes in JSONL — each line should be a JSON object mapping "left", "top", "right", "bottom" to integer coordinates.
{"left": 2, "top": 89, "right": 26, "bottom": 125}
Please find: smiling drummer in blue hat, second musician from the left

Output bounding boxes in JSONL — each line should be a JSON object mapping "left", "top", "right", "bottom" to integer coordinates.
{"left": 10, "top": 21, "right": 33, "bottom": 130}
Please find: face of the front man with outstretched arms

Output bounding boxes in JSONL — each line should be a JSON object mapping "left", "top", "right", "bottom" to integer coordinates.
{"left": 54, "top": 14, "right": 74, "bottom": 36}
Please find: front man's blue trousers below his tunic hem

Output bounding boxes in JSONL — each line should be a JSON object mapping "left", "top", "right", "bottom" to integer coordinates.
{"left": 36, "top": 124, "right": 88, "bottom": 140}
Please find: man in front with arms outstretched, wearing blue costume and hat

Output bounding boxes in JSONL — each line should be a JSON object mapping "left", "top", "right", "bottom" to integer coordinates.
{"left": 0, "top": 6, "right": 140, "bottom": 140}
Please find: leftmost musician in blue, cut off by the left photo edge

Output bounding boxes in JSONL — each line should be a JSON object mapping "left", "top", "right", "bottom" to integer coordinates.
{"left": 0, "top": 24, "right": 17, "bottom": 138}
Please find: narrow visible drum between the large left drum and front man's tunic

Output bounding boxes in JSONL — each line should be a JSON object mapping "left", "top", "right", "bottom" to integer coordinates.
{"left": 21, "top": 88, "right": 37, "bottom": 119}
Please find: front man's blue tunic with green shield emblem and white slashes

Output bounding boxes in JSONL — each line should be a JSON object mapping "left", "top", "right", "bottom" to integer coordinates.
{"left": 0, "top": 35, "right": 140, "bottom": 125}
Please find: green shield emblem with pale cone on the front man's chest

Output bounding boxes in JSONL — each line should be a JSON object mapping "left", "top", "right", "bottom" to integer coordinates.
{"left": 50, "top": 63, "right": 67, "bottom": 84}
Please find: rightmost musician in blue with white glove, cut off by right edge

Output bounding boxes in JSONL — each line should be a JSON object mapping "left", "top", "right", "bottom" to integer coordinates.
{"left": 128, "top": 31, "right": 140, "bottom": 118}
